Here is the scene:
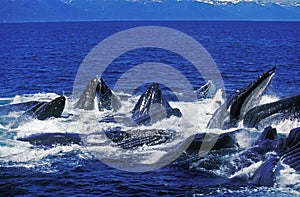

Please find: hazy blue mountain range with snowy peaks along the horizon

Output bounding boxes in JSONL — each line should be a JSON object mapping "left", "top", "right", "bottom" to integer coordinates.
{"left": 0, "top": 0, "right": 300, "bottom": 22}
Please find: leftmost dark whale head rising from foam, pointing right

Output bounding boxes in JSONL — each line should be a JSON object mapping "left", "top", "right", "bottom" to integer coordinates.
{"left": 11, "top": 96, "right": 66, "bottom": 129}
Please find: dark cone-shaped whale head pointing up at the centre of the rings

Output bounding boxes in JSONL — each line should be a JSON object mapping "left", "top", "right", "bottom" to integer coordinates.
{"left": 131, "top": 83, "right": 182, "bottom": 124}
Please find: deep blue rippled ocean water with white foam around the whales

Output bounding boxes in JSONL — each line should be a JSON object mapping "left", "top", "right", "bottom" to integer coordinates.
{"left": 0, "top": 21, "right": 300, "bottom": 196}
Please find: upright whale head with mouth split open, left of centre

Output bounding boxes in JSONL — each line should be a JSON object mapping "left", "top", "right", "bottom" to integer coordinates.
{"left": 75, "top": 77, "right": 121, "bottom": 111}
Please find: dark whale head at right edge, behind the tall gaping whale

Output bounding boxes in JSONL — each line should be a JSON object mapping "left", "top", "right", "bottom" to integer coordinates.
{"left": 243, "top": 95, "right": 300, "bottom": 128}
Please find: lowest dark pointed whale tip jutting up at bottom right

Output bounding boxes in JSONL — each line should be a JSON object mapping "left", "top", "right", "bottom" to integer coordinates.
{"left": 250, "top": 156, "right": 279, "bottom": 187}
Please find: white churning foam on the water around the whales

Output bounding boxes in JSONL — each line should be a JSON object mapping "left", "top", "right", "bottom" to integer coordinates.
{"left": 0, "top": 92, "right": 300, "bottom": 176}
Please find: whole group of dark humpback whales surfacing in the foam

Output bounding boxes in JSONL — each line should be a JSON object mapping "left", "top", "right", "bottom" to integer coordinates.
{"left": 0, "top": 68, "right": 300, "bottom": 186}
